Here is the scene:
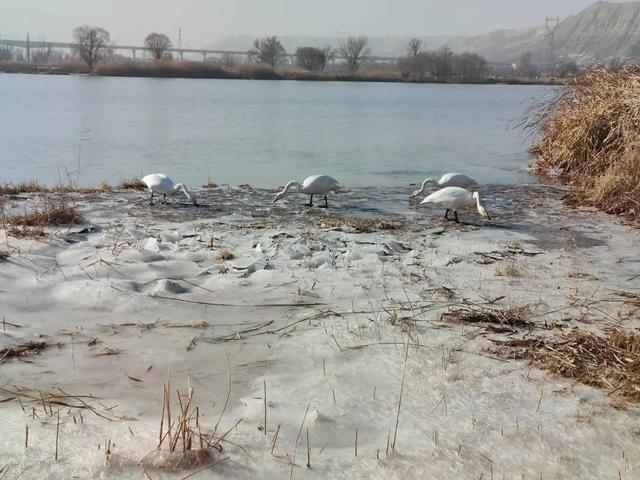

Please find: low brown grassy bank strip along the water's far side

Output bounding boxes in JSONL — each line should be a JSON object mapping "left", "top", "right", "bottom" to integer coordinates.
{"left": 0, "top": 62, "right": 564, "bottom": 85}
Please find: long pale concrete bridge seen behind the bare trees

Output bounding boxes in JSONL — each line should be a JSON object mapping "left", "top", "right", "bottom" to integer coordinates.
{"left": 0, "top": 38, "right": 396, "bottom": 63}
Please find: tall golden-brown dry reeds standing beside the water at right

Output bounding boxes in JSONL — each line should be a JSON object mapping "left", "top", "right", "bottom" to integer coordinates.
{"left": 523, "top": 65, "right": 640, "bottom": 221}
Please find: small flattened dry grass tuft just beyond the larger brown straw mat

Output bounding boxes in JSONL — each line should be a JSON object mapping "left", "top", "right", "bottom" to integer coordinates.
{"left": 442, "top": 302, "right": 533, "bottom": 333}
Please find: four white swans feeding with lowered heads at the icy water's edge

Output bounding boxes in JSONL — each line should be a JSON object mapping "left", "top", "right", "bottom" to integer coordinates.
{"left": 142, "top": 172, "right": 491, "bottom": 222}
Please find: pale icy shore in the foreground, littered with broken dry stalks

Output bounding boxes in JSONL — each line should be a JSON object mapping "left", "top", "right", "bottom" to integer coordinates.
{"left": 0, "top": 185, "right": 640, "bottom": 479}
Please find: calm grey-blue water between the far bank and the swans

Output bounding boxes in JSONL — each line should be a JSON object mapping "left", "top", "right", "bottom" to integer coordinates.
{"left": 0, "top": 74, "right": 547, "bottom": 187}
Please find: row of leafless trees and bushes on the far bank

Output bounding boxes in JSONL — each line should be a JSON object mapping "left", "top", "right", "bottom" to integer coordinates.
{"left": 0, "top": 25, "right": 578, "bottom": 82}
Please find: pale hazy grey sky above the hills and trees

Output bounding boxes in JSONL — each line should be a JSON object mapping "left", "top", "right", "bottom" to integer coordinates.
{"left": 0, "top": 0, "right": 608, "bottom": 47}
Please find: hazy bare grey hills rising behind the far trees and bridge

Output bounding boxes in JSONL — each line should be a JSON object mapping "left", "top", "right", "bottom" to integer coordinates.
{"left": 207, "top": 2, "right": 640, "bottom": 65}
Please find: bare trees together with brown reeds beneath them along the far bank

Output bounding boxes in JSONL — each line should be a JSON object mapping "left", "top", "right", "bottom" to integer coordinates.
{"left": 0, "top": 29, "right": 558, "bottom": 84}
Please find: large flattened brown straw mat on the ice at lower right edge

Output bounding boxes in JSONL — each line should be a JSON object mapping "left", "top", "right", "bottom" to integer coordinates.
{"left": 495, "top": 328, "right": 640, "bottom": 401}
